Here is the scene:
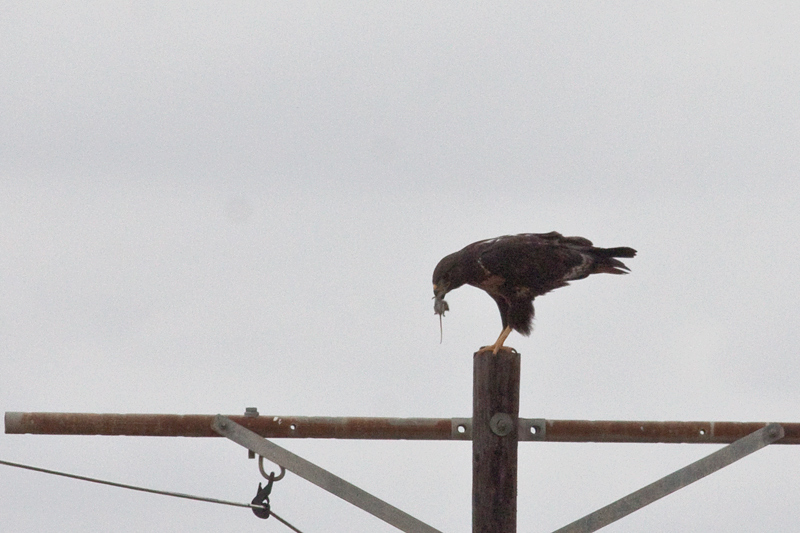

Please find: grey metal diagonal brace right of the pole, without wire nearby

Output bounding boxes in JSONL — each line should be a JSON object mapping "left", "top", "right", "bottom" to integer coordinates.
{"left": 554, "top": 424, "right": 784, "bottom": 533}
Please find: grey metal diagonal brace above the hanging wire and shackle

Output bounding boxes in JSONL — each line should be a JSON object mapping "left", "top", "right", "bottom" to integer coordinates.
{"left": 211, "top": 415, "right": 441, "bottom": 533}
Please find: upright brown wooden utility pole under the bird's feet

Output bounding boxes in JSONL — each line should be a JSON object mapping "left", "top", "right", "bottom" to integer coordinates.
{"left": 472, "top": 349, "right": 520, "bottom": 533}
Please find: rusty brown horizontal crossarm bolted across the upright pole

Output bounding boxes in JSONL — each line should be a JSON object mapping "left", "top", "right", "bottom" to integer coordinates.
{"left": 5, "top": 412, "right": 800, "bottom": 444}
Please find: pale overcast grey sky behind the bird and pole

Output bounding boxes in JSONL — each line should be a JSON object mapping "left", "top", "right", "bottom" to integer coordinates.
{"left": 0, "top": 2, "right": 800, "bottom": 533}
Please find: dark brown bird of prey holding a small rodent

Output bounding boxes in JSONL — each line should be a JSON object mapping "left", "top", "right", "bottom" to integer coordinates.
{"left": 433, "top": 231, "right": 636, "bottom": 354}
